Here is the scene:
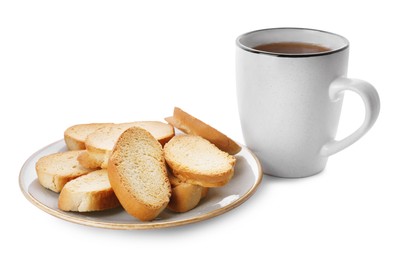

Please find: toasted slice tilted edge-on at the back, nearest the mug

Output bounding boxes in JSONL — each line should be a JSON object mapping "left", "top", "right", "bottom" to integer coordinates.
{"left": 165, "top": 107, "right": 241, "bottom": 155}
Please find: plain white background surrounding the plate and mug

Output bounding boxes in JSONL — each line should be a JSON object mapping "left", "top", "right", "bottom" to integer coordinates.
{"left": 0, "top": 0, "right": 399, "bottom": 259}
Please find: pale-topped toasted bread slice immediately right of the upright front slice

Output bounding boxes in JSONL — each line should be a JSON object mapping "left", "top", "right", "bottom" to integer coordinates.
{"left": 164, "top": 135, "right": 236, "bottom": 187}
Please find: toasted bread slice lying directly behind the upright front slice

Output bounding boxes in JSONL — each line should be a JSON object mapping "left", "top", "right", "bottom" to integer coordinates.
{"left": 78, "top": 121, "right": 175, "bottom": 169}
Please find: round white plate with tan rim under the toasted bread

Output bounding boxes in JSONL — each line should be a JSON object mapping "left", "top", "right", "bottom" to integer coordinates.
{"left": 19, "top": 140, "right": 263, "bottom": 229}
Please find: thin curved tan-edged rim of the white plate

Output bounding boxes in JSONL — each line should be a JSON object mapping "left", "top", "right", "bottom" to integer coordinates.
{"left": 18, "top": 139, "right": 263, "bottom": 230}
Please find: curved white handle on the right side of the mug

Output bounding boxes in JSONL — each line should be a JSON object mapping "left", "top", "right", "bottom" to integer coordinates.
{"left": 321, "top": 78, "right": 380, "bottom": 156}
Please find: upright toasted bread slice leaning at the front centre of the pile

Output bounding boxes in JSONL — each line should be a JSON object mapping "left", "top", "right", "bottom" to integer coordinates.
{"left": 108, "top": 127, "right": 171, "bottom": 221}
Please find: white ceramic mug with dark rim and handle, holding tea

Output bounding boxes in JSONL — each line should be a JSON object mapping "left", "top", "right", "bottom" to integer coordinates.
{"left": 236, "top": 28, "right": 380, "bottom": 178}
